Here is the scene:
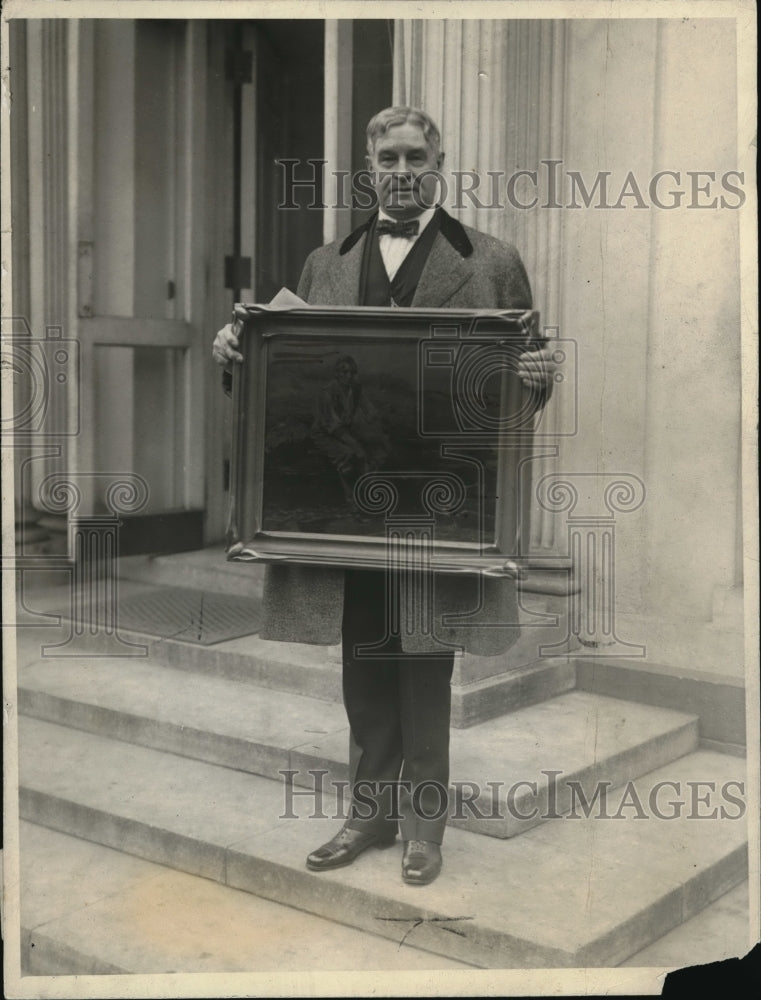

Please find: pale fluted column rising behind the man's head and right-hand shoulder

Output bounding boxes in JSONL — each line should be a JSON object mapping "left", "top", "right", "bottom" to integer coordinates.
{"left": 394, "top": 19, "right": 575, "bottom": 556}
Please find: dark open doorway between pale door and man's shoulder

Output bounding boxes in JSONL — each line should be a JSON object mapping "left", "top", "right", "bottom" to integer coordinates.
{"left": 205, "top": 20, "right": 324, "bottom": 544}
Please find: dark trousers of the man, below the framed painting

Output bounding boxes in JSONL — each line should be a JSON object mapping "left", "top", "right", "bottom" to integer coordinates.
{"left": 342, "top": 570, "right": 454, "bottom": 844}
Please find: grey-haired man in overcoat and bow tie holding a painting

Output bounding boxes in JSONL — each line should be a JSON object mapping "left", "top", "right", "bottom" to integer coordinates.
{"left": 214, "top": 107, "right": 552, "bottom": 885}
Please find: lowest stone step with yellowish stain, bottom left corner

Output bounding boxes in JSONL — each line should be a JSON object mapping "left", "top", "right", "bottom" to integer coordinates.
{"left": 19, "top": 822, "right": 472, "bottom": 976}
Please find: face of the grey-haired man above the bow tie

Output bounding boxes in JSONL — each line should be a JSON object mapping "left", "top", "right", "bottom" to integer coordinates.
{"left": 367, "top": 122, "right": 444, "bottom": 219}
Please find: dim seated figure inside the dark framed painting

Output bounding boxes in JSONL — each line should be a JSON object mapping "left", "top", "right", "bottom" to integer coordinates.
{"left": 311, "top": 354, "right": 389, "bottom": 503}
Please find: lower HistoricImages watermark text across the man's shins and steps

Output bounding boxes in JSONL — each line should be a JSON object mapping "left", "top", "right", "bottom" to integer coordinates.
{"left": 278, "top": 768, "right": 746, "bottom": 822}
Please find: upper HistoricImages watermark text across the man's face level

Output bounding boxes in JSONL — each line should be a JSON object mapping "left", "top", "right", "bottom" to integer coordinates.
{"left": 276, "top": 158, "right": 746, "bottom": 211}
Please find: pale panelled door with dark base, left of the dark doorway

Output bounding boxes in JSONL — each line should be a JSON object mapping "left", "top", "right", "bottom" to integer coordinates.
{"left": 76, "top": 20, "right": 207, "bottom": 554}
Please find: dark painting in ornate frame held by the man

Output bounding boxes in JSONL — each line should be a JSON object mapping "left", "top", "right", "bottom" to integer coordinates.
{"left": 227, "top": 306, "right": 540, "bottom": 576}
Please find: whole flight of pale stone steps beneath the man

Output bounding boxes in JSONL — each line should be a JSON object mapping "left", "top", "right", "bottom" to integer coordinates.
{"left": 11, "top": 560, "right": 747, "bottom": 974}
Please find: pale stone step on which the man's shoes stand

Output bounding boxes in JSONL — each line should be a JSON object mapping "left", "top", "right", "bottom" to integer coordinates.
{"left": 19, "top": 718, "right": 747, "bottom": 968}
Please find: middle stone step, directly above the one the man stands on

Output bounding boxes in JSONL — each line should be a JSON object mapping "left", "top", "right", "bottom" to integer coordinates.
{"left": 19, "top": 659, "right": 698, "bottom": 837}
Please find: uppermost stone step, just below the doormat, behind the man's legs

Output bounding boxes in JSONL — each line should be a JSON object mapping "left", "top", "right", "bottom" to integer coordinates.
{"left": 16, "top": 580, "right": 576, "bottom": 728}
